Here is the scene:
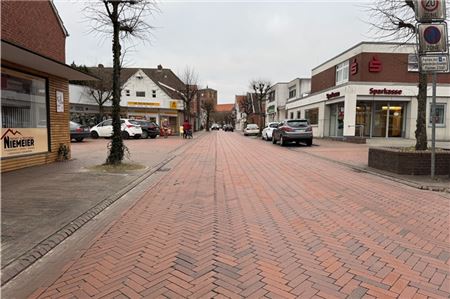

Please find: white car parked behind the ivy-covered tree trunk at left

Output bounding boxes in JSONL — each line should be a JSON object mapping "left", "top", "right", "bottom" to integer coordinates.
{"left": 91, "top": 119, "right": 142, "bottom": 139}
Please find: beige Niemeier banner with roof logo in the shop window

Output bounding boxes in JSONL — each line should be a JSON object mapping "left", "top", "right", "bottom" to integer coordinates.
{"left": 1, "top": 128, "right": 48, "bottom": 158}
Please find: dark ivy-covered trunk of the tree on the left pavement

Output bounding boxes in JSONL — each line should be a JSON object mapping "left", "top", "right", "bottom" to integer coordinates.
{"left": 106, "top": 1, "right": 124, "bottom": 165}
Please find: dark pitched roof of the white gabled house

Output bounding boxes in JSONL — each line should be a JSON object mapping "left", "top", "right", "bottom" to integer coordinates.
{"left": 88, "top": 67, "right": 185, "bottom": 100}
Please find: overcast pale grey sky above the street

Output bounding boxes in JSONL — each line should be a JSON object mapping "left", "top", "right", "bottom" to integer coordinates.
{"left": 54, "top": 0, "right": 371, "bottom": 103}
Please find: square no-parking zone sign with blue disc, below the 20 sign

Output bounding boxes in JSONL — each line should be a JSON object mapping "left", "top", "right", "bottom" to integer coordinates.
{"left": 419, "top": 23, "right": 447, "bottom": 54}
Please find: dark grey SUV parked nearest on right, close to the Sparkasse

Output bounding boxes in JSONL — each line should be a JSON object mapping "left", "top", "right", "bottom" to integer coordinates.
{"left": 272, "top": 119, "right": 313, "bottom": 146}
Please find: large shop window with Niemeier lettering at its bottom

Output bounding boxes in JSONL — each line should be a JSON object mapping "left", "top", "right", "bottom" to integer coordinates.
{"left": 1, "top": 68, "right": 48, "bottom": 158}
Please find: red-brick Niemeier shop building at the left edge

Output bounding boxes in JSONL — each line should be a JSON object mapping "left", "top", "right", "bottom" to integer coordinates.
{"left": 1, "top": 1, "right": 95, "bottom": 172}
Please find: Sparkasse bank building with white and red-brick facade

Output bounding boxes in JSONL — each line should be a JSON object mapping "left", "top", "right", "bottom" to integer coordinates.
{"left": 286, "top": 42, "right": 450, "bottom": 140}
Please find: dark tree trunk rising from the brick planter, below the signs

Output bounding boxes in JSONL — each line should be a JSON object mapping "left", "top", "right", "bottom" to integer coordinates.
{"left": 415, "top": 73, "right": 428, "bottom": 150}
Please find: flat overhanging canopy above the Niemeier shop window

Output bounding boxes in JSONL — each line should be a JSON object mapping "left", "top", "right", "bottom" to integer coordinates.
{"left": 1, "top": 40, "right": 98, "bottom": 81}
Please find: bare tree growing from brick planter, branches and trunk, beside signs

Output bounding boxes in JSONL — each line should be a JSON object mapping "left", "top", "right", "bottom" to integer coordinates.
{"left": 367, "top": 0, "right": 446, "bottom": 150}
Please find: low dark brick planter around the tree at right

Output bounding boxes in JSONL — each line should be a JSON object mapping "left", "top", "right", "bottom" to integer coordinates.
{"left": 369, "top": 148, "right": 450, "bottom": 175}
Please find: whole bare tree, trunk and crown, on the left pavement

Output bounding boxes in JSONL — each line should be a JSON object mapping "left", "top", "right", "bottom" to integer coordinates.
{"left": 86, "top": 0, "right": 156, "bottom": 165}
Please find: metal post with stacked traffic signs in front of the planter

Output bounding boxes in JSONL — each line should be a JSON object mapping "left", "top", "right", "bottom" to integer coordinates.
{"left": 414, "top": 0, "right": 450, "bottom": 179}
